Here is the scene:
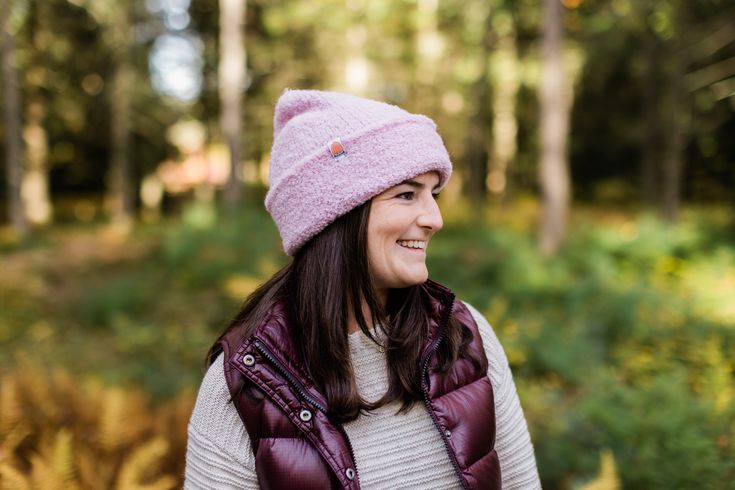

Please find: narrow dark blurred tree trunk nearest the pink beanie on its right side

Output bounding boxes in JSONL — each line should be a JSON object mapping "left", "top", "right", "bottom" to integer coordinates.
{"left": 465, "top": 3, "right": 494, "bottom": 212}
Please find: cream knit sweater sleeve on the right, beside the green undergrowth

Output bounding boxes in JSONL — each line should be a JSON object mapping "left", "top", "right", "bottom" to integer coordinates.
{"left": 465, "top": 303, "right": 541, "bottom": 490}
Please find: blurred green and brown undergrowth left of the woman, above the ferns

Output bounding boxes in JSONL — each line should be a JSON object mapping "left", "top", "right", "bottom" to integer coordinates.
{"left": 0, "top": 207, "right": 284, "bottom": 396}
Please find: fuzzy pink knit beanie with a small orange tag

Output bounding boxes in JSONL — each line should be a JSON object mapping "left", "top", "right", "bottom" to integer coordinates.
{"left": 265, "top": 90, "right": 452, "bottom": 255}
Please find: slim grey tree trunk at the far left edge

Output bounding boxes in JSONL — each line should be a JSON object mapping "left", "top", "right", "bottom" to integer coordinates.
{"left": 0, "top": 0, "right": 28, "bottom": 240}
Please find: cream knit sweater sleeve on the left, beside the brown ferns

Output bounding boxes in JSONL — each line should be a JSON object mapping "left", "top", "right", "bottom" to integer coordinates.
{"left": 184, "top": 354, "right": 259, "bottom": 490}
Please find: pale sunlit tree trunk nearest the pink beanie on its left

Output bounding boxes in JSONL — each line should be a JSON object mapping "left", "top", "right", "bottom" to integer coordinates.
{"left": 219, "top": 0, "right": 247, "bottom": 207}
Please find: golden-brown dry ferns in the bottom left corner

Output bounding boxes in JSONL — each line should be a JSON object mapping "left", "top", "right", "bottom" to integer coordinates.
{"left": 0, "top": 357, "right": 194, "bottom": 490}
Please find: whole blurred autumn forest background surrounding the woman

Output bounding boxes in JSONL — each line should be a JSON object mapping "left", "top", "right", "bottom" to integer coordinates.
{"left": 0, "top": 0, "right": 735, "bottom": 489}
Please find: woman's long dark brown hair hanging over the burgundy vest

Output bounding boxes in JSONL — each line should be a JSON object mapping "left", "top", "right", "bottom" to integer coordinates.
{"left": 213, "top": 201, "right": 476, "bottom": 422}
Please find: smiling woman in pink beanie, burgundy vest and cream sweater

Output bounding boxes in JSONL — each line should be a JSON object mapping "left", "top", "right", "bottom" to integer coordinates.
{"left": 186, "top": 90, "right": 540, "bottom": 489}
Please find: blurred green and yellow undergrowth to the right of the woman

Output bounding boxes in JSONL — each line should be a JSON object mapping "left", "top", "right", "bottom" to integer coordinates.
{"left": 430, "top": 209, "right": 735, "bottom": 489}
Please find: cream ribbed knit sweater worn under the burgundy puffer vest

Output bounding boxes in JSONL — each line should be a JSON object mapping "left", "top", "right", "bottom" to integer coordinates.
{"left": 185, "top": 305, "right": 541, "bottom": 490}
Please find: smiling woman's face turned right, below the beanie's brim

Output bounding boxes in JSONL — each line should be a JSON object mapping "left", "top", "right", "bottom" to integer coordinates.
{"left": 368, "top": 172, "right": 444, "bottom": 294}
